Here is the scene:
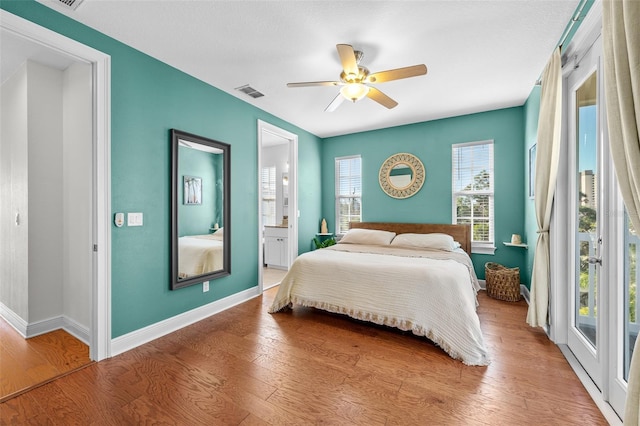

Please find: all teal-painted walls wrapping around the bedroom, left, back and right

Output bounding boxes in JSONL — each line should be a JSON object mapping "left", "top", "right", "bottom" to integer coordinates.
{"left": 7, "top": 0, "right": 592, "bottom": 337}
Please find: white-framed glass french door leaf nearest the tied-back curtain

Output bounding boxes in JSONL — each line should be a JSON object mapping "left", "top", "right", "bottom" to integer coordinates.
{"left": 568, "top": 41, "right": 607, "bottom": 389}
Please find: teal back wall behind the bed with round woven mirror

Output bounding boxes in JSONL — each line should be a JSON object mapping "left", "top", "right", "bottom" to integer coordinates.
{"left": 322, "top": 107, "right": 526, "bottom": 278}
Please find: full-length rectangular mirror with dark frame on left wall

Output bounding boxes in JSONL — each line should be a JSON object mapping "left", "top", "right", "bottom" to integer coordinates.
{"left": 171, "top": 129, "right": 231, "bottom": 290}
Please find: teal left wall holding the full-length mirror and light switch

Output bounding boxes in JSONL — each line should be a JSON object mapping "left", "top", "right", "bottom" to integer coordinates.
{"left": 0, "top": 0, "right": 321, "bottom": 337}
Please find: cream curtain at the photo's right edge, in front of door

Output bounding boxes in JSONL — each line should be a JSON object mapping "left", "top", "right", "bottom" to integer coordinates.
{"left": 602, "top": 0, "right": 640, "bottom": 425}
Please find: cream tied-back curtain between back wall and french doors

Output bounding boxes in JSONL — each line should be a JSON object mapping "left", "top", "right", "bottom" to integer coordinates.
{"left": 527, "top": 48, "right": 562, "bottom": 327}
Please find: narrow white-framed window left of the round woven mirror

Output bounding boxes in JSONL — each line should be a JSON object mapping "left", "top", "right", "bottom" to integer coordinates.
{"left": 336, "top": 155, "right": 362, "bottom": 235}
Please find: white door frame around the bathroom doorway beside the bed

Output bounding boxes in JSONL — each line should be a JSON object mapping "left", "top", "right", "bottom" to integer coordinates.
{"left": 257, "top": 119, "right": 300, "bottom": 293}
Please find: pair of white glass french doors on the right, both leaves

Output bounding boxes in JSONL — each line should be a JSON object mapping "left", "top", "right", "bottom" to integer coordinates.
{"left": 562, "top": 31, "right": 640, "bottom": 417}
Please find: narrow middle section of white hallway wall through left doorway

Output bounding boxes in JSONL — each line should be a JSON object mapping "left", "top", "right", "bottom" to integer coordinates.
{"left": 27, "top": 61, "right": 63, "bottom": 323}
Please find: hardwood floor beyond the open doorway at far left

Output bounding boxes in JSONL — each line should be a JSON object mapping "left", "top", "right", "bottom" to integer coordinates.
{"left": 0, "top": 318, "right": 91, "bottom": 402}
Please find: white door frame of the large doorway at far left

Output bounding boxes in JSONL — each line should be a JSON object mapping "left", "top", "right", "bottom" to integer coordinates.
{"left": 0, "top": 9, "right": 111, "bottom": 361}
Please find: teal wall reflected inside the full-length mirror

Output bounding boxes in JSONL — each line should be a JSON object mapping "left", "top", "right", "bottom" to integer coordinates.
{"left": 178, "top": 146, "right": 223, "bottom": 237}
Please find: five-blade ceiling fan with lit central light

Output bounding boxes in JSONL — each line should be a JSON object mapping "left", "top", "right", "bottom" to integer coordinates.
{"left": 287, "top": 44, "right": 427, "bottom": 112}
